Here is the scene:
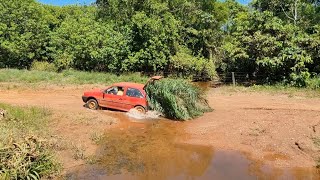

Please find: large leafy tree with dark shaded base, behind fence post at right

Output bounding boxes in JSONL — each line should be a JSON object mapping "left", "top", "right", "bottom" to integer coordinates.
{"left": 224, "top": 11, "right": 312, "bottom": 81}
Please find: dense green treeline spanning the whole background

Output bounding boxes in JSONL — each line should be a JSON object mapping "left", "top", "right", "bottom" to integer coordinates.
{"left": 0, "top": 0, "right": 320, "bottom": 86}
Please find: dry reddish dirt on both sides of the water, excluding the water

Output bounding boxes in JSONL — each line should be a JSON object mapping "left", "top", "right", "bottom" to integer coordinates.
{"left": 0, "top": 86, "right": 320, "bottom": 169}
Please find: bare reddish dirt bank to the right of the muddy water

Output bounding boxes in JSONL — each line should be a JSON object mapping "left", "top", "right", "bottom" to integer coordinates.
{"left": 187, "top": 88, "right": 320, "bottom": 167}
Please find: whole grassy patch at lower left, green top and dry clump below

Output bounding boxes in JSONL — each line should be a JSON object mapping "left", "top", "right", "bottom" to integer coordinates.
{"left": 0, "top": 104, "right": 59, "bottom": 179}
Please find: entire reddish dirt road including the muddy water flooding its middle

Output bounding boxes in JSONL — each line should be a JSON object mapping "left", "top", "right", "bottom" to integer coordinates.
{"left": 0, "top": 86, "right": 320, "bottom": 179}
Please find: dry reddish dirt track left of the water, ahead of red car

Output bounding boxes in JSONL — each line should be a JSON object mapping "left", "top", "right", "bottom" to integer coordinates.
{"left": 0, "top": 84, "right": 117, "bottom": 171}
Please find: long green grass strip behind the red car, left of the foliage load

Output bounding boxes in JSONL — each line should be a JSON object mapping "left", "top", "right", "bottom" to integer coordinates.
{"left": 0, "top": 69, "right": 148, "bottom": 85}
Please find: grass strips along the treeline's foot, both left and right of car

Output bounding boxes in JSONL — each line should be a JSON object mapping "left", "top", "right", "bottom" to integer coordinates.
{"left": 0, "top": 69, "right": 320, "bottom": 94}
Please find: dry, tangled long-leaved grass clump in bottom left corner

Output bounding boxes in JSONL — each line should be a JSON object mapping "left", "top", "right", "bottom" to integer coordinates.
{"left": 0, "top": 137, "right": 59, "bottom": 179}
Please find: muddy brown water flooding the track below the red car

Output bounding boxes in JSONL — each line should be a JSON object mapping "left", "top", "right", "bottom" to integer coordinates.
{"left": 66, "top": 112, "right": 320, "bottom": 180}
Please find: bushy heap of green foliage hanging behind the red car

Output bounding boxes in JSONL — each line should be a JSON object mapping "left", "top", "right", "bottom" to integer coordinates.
{"left": 145, "top": 79, "right": 212, "bottom": 120}
